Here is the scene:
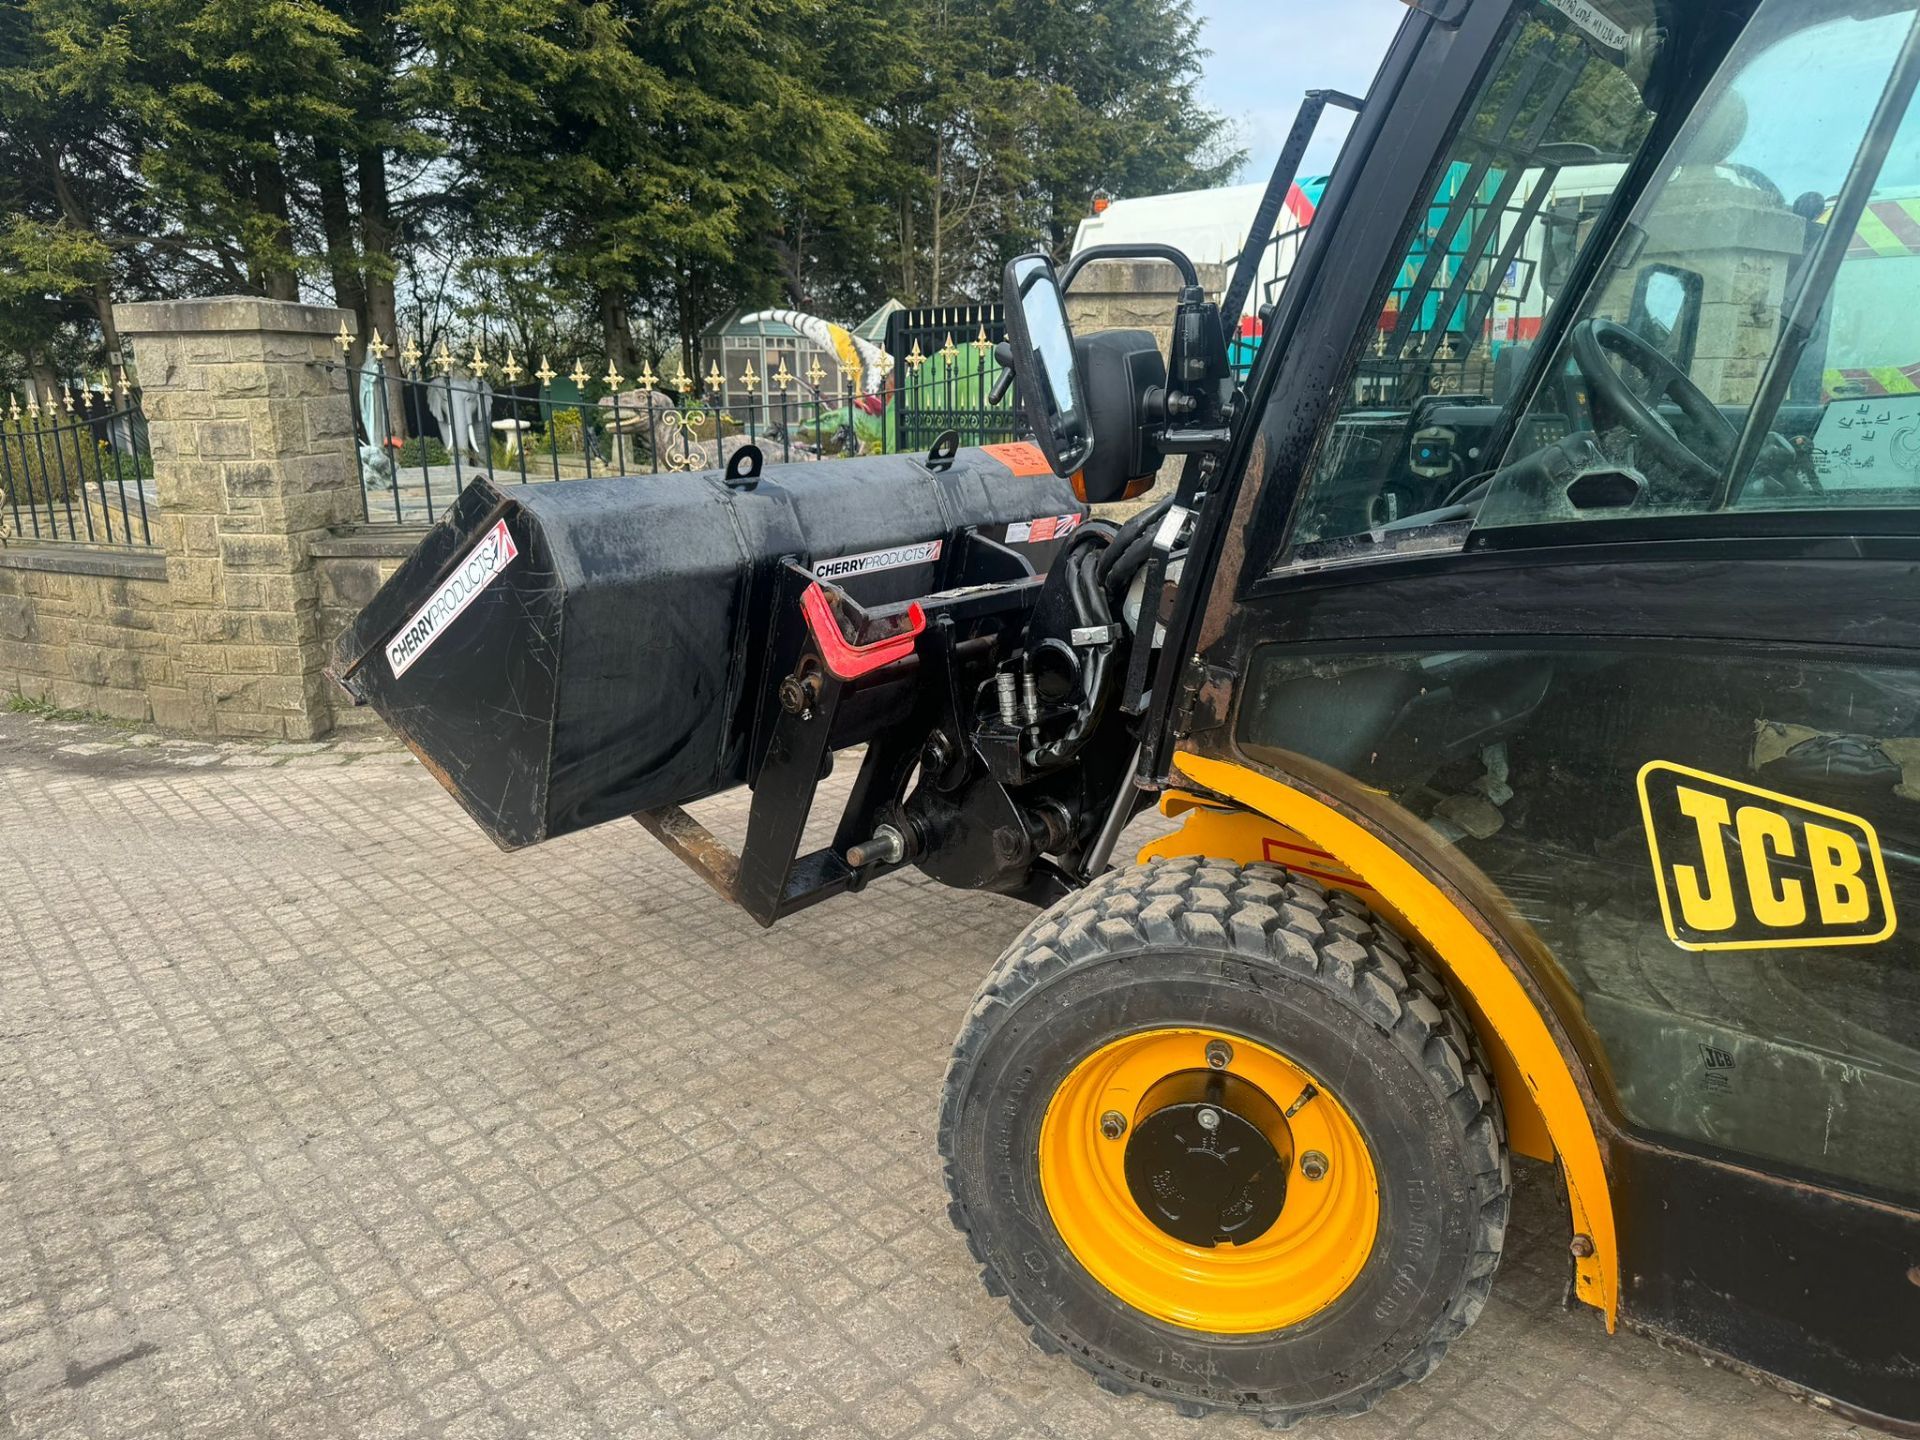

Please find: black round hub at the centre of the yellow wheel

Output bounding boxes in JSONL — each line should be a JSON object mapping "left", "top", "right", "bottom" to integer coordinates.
{"left": 1125, "top": 1069, "right": 1294, "bottom": 1250}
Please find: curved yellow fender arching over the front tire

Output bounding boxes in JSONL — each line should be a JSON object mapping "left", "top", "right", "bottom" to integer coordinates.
{"left": 1140, "top": 755, "right": 1620, "bottom": 1331}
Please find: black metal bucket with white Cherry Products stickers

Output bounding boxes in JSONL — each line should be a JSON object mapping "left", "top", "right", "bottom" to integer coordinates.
{"left": 332, "top": 447, "right": 1085, "bottom": 849}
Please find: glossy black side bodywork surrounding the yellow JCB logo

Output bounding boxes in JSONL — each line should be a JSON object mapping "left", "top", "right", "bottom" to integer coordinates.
{"left": 1188, "top": 536, "right": 1920, "bottom": 1432}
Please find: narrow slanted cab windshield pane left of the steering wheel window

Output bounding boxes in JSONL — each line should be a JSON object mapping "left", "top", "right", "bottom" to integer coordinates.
{"left": 1290, "top": 0, "right": 1667, "bottom": 559}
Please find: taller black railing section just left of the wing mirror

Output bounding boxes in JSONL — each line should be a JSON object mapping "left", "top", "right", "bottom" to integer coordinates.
{"left": 887, "top": 305, "right": 1021, "bottom": 453}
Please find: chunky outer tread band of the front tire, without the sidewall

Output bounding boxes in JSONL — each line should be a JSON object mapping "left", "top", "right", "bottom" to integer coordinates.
{"left": 939, "top": 856, "right": 1511, "bottom": 1430}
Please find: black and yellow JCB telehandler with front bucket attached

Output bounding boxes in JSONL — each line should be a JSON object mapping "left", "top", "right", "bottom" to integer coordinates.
{"left": 336, "top": 0, "right": 1920, "bottom": 1434}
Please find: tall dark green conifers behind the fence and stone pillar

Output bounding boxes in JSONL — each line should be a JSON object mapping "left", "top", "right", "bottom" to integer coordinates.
{"left": 0, "top": 0, "right": 1236, "bottom": 374}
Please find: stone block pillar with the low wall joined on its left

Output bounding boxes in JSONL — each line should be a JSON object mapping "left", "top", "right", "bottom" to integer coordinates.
{"left": 0, "top": 298, "right": 361, "bottom": 739}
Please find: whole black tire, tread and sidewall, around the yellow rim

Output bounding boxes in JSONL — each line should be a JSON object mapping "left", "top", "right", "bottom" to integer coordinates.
{"left": 939, "top": 858, "right": 1511, "bottom": 1428}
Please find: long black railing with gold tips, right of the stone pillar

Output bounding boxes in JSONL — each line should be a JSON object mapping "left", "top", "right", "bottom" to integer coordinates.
{"left": 330, "top": 347, "right": 887, "bottom": 524}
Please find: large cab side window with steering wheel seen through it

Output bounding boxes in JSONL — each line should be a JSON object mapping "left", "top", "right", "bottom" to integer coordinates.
{"left": 1476, "top": 0, "right": 1920, "bottom": 530}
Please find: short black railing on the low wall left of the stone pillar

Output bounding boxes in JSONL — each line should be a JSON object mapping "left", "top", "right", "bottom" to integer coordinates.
{"left": 0, "top": 382, "right": 154, "bottom": 545}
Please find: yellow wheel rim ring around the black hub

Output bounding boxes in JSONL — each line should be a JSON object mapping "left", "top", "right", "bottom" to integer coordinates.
{"left": 1041, "top": 1029, "right": 1380, "bottom": 1334}
